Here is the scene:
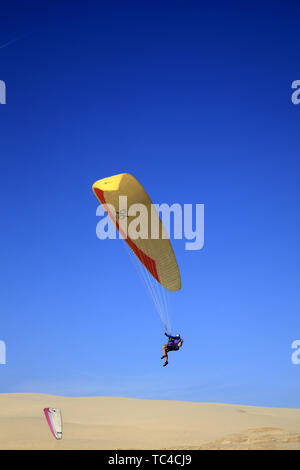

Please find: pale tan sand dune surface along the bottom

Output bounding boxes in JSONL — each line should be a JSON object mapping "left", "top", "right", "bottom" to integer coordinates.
{"left": 0, "top": 394, "right": 300, "bottom": 450}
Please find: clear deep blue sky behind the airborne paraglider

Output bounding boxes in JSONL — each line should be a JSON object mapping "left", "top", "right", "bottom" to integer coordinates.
{"left": 0, "top": 1, "right": 300, "bottom": 407}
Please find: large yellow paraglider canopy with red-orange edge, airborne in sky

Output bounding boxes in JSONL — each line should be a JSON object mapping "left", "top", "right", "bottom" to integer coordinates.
{"left": 93, "top": 173, "right": 181, "bottom": 291}
